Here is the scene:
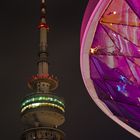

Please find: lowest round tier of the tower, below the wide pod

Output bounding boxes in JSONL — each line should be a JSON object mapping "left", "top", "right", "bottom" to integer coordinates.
{"left": 21, "top": 127, "right": 64, "bottom": 140}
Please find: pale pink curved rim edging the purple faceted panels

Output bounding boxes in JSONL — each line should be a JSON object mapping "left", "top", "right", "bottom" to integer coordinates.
{"left": 80, "top": 0, "right": 140, "bottom": 138}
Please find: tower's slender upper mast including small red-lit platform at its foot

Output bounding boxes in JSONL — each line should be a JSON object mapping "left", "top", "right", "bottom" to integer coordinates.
{"left": 28, "top": 0, "right": 58, "bottom": 93}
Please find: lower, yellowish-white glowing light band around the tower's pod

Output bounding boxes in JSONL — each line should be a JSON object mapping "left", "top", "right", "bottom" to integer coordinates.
{"left": 21, "top": 103, "right": 65, "bottom": 113}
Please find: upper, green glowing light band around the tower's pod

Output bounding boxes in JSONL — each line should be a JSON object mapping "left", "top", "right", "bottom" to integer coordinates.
{"left": 21, "top": 96, "right": 65, "bottom": 107}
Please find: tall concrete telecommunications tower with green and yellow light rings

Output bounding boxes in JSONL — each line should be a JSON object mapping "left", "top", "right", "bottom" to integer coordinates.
{"left": 21, "top": 0, "right": 65, "bottom": 140}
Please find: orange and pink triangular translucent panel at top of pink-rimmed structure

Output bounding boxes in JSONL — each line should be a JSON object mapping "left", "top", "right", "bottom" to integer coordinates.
{"left": 101, "top": 0, "right": 140, "bottom": 26}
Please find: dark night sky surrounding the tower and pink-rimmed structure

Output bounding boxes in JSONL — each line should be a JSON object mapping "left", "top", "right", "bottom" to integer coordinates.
{"left": 0, "top": 0, "right": 138, "bottom": 140}
